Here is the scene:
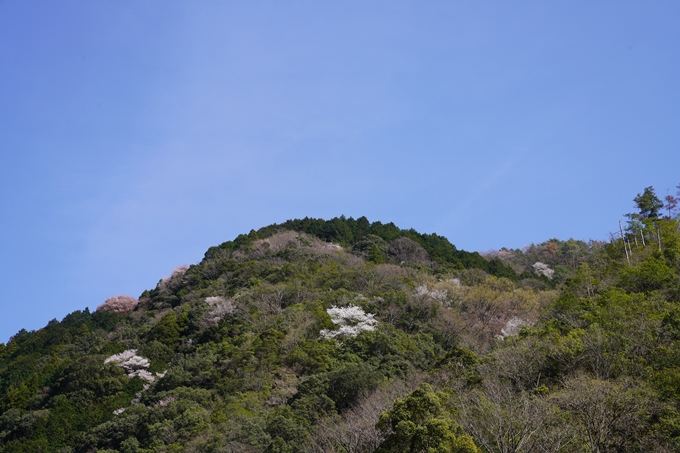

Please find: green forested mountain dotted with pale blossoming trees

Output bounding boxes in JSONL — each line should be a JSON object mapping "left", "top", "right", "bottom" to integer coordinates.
{"left": 0, "top": 187, "right": 680, "bottom": 453}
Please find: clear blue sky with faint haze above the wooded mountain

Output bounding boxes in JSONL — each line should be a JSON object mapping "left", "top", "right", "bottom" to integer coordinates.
{"left": 0, "top": 0, "right": 680, "bottom": 341}
